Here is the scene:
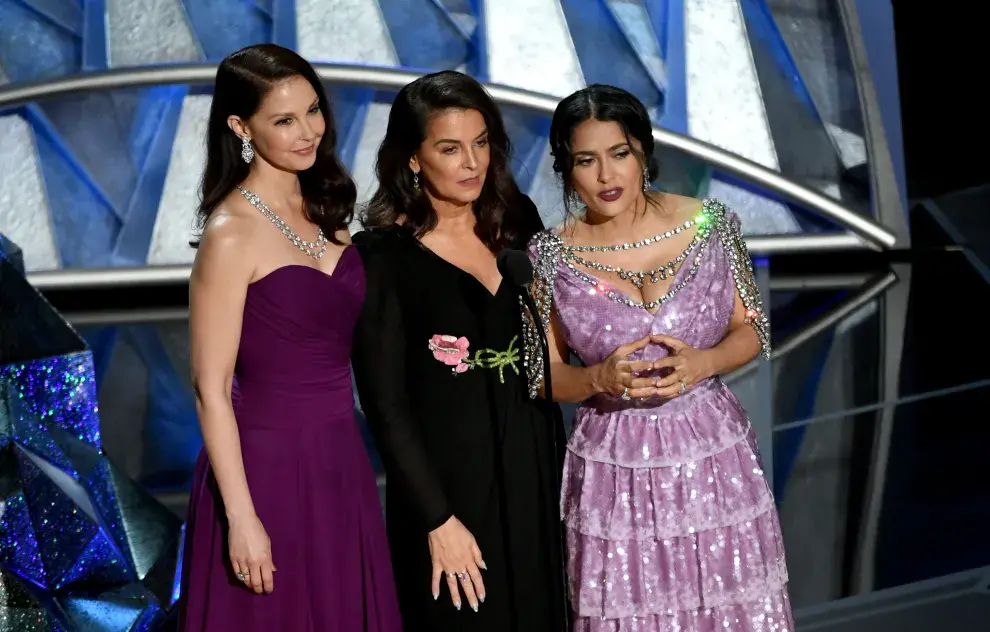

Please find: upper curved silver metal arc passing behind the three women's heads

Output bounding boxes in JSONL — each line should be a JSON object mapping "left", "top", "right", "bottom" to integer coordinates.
{"left": 0, "top": 63, "right": 897, "bottom": 249}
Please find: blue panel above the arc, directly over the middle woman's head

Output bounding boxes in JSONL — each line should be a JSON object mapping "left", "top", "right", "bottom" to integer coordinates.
{"left": 378, "top": 0, "right": 482, "bottom": 71}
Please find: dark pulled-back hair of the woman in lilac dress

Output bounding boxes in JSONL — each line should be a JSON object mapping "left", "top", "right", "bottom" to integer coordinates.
{"left": 550, "top": 84, "right": 660, "bottom": 212}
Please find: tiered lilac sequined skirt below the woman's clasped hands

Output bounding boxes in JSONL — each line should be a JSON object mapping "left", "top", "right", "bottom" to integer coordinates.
{"left": 561, "top": 379, "right": 794, "bottom": 632}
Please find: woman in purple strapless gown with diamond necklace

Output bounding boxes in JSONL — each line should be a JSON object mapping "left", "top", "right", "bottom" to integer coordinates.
{"left": 179, "top": 44, "right": 401, "bottom": 632}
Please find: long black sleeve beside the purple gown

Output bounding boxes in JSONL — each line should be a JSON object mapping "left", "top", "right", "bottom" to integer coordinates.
{"left": 351, "top": 231, "right": 452, "bottom": 532}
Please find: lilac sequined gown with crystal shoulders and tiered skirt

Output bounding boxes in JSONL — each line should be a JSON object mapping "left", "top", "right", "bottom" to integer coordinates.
{"left": 530, "top": 202, "right": 793, "bottom": 632}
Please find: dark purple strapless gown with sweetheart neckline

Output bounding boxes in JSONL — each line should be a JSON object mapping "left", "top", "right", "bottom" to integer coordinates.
{"left": 179, "top": 248, "right": 402, "bottom": 632}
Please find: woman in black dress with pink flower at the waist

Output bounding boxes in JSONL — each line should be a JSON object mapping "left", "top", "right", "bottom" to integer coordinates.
{"left": 352, "top": 71, "right": 567, "bottom": 632}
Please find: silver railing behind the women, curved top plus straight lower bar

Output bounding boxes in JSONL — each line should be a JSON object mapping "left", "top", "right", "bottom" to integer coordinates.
{"left": 0, "top": 63, "right": 897, "bottom": 289}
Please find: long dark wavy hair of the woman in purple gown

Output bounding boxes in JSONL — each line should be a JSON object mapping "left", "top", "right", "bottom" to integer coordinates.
{"left": 197, "top": 44, "right": 357, "bottom": 243}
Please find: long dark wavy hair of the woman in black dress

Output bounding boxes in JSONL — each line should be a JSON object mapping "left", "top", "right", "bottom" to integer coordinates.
{"left": 361, "top": 70, "right": 532, "bottom": 252}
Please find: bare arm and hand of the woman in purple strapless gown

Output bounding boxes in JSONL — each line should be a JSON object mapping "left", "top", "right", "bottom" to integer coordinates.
{"left": 189, "top": 216, "right": 274, "bottom": 593}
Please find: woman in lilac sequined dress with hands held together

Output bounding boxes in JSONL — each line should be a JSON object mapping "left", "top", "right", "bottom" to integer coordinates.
{"left": 530, "top": 86, "right": 793, "bottom": 632}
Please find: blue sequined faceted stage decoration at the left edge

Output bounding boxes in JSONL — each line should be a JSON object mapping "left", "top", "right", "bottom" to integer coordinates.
{"left": 0, "top": 236, "right": 181, "bottom": 632}
